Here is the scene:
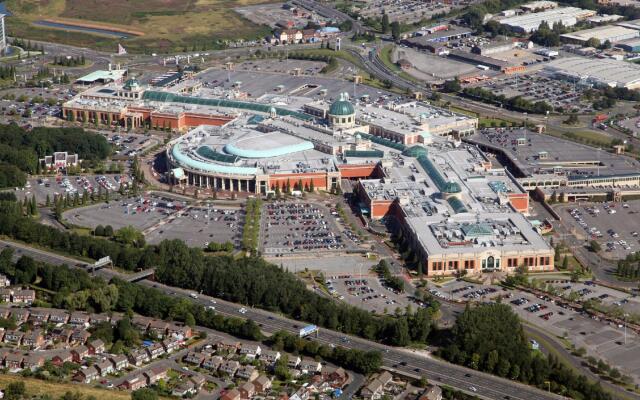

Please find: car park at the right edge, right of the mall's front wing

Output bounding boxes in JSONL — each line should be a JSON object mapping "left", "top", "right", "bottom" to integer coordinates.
{"left": 565, "top": 200, "right": 640, "bottom": 259}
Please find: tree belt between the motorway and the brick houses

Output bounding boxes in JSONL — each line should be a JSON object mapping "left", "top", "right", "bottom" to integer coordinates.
{"left": 0, "top": 248, "right": 382, "bottom": 374}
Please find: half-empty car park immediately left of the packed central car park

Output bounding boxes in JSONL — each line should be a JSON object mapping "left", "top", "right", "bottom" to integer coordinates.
{"left": 146, "top": 205, "right": 245, "bottom": 248}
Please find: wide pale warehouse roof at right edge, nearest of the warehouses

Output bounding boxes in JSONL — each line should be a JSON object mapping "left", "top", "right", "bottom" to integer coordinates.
{"left": 544, "top": 57, "right": 640, "bottom": 89}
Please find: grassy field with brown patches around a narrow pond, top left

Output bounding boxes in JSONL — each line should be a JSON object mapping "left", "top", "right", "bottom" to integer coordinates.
{"left": 6, "top": 0, "right": 271, "bottom": 53}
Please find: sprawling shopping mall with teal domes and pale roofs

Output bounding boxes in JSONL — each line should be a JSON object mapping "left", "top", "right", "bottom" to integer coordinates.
{"left": 63, "top": 79, "right": 554, "bottom": 276}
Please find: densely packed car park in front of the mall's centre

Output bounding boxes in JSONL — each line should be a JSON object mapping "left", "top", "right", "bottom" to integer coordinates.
{"left": 261, "top": 201, "right": 358, "bottom": 257}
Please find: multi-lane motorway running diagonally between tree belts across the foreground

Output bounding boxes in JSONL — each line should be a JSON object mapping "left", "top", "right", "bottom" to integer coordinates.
{"left": 0, "top": 240, "right": 563, "bottom": 400}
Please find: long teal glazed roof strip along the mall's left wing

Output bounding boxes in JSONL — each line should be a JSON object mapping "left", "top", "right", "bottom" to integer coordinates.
{"left": 142, "top": 90, "right": 313, "bottom": 121}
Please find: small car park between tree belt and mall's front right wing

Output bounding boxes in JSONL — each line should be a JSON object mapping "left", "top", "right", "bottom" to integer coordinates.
{"left": 325, "top": 273, "right": 410, "bottom": 314}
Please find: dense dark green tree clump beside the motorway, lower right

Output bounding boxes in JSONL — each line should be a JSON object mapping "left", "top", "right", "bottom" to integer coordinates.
{"left": 440, "top": 304, "right": 611, "bottom": 400}
